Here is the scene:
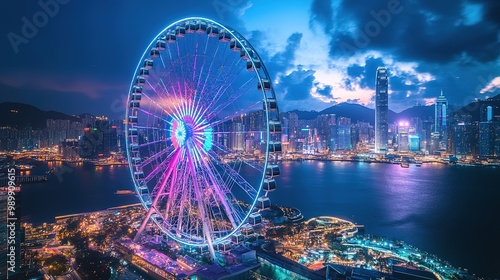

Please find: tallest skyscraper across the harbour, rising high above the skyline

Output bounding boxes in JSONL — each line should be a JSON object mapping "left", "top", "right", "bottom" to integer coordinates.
{"left": 375, "top": 67, "right": 389, "bottom": 153}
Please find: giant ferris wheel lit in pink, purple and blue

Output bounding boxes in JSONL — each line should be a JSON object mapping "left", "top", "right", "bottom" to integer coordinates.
{"left": 125, "top": 17, "right": 282, "bottom": 257}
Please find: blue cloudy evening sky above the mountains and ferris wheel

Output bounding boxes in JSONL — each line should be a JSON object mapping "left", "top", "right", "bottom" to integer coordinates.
{"left": 0, "top": 0, "right": 500, "bottom": 118}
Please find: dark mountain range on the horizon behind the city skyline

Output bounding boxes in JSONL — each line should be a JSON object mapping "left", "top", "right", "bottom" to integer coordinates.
{"left": 0, "top": 94, "right": 500, "bottom": 129}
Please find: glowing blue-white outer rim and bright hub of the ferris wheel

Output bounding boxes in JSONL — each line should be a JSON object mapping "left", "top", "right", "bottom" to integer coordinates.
{"left": 125, "top": 17, "right": 281, "bottom": 249}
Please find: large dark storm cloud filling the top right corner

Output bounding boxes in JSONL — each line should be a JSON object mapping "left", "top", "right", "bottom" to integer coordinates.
{"left": 320, "top": 0, "right": 500, "bottom": 63}
